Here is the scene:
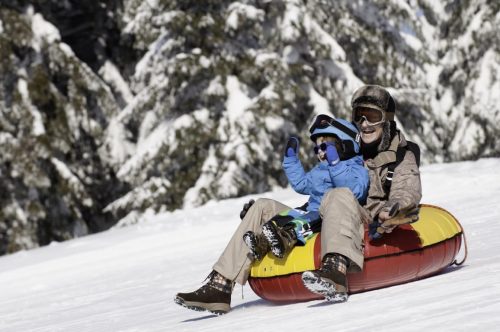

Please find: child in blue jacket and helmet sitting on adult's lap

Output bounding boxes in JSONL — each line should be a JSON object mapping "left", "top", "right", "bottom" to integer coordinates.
{"left": 243, "top": 114, "right": 369, "bottom": 260}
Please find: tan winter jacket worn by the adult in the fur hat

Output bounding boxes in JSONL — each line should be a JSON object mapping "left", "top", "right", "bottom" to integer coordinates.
{"left": 363, "top": 132, "right": 422, "bottom": 223}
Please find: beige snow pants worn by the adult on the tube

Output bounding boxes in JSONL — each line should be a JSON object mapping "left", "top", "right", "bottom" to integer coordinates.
{"left": 213, "top": 188, "right": 364, "bottom": 285}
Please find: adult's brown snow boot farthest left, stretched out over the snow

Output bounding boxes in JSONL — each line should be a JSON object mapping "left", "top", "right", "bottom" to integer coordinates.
{"left": 174, "top": 271, "right": 234, "bottom": 315}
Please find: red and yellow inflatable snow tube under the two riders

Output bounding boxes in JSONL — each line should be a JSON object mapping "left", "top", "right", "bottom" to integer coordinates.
{"left": 248, "top": 204, "right": 463, "bottom": 302}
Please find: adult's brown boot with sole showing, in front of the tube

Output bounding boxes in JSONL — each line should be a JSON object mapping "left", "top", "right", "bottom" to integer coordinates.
{"left": 302, "top": 254, "right": 349, "bottom": 302}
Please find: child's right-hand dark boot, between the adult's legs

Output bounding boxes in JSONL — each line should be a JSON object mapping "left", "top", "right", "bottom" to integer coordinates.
{"left": 262, "top": 220, "right": 297, "bottom": 258}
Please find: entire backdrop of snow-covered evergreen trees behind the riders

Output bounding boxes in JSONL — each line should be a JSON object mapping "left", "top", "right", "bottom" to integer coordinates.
{"left": 0, "top": 0, "right": 500, "bottom": 253}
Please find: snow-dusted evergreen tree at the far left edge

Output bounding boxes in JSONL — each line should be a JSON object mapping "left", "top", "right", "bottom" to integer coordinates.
{"left": 0, "top": 9, "right": 127, "bottom": 253}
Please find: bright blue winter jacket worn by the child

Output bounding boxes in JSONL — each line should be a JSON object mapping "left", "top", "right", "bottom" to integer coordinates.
{"left": 283, "top": 156, "right": 369, "bottom": 211}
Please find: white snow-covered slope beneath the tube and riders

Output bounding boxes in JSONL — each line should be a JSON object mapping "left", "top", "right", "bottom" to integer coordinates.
{"left": 0, "top": 159, "right": 500, "bottom": 332}
